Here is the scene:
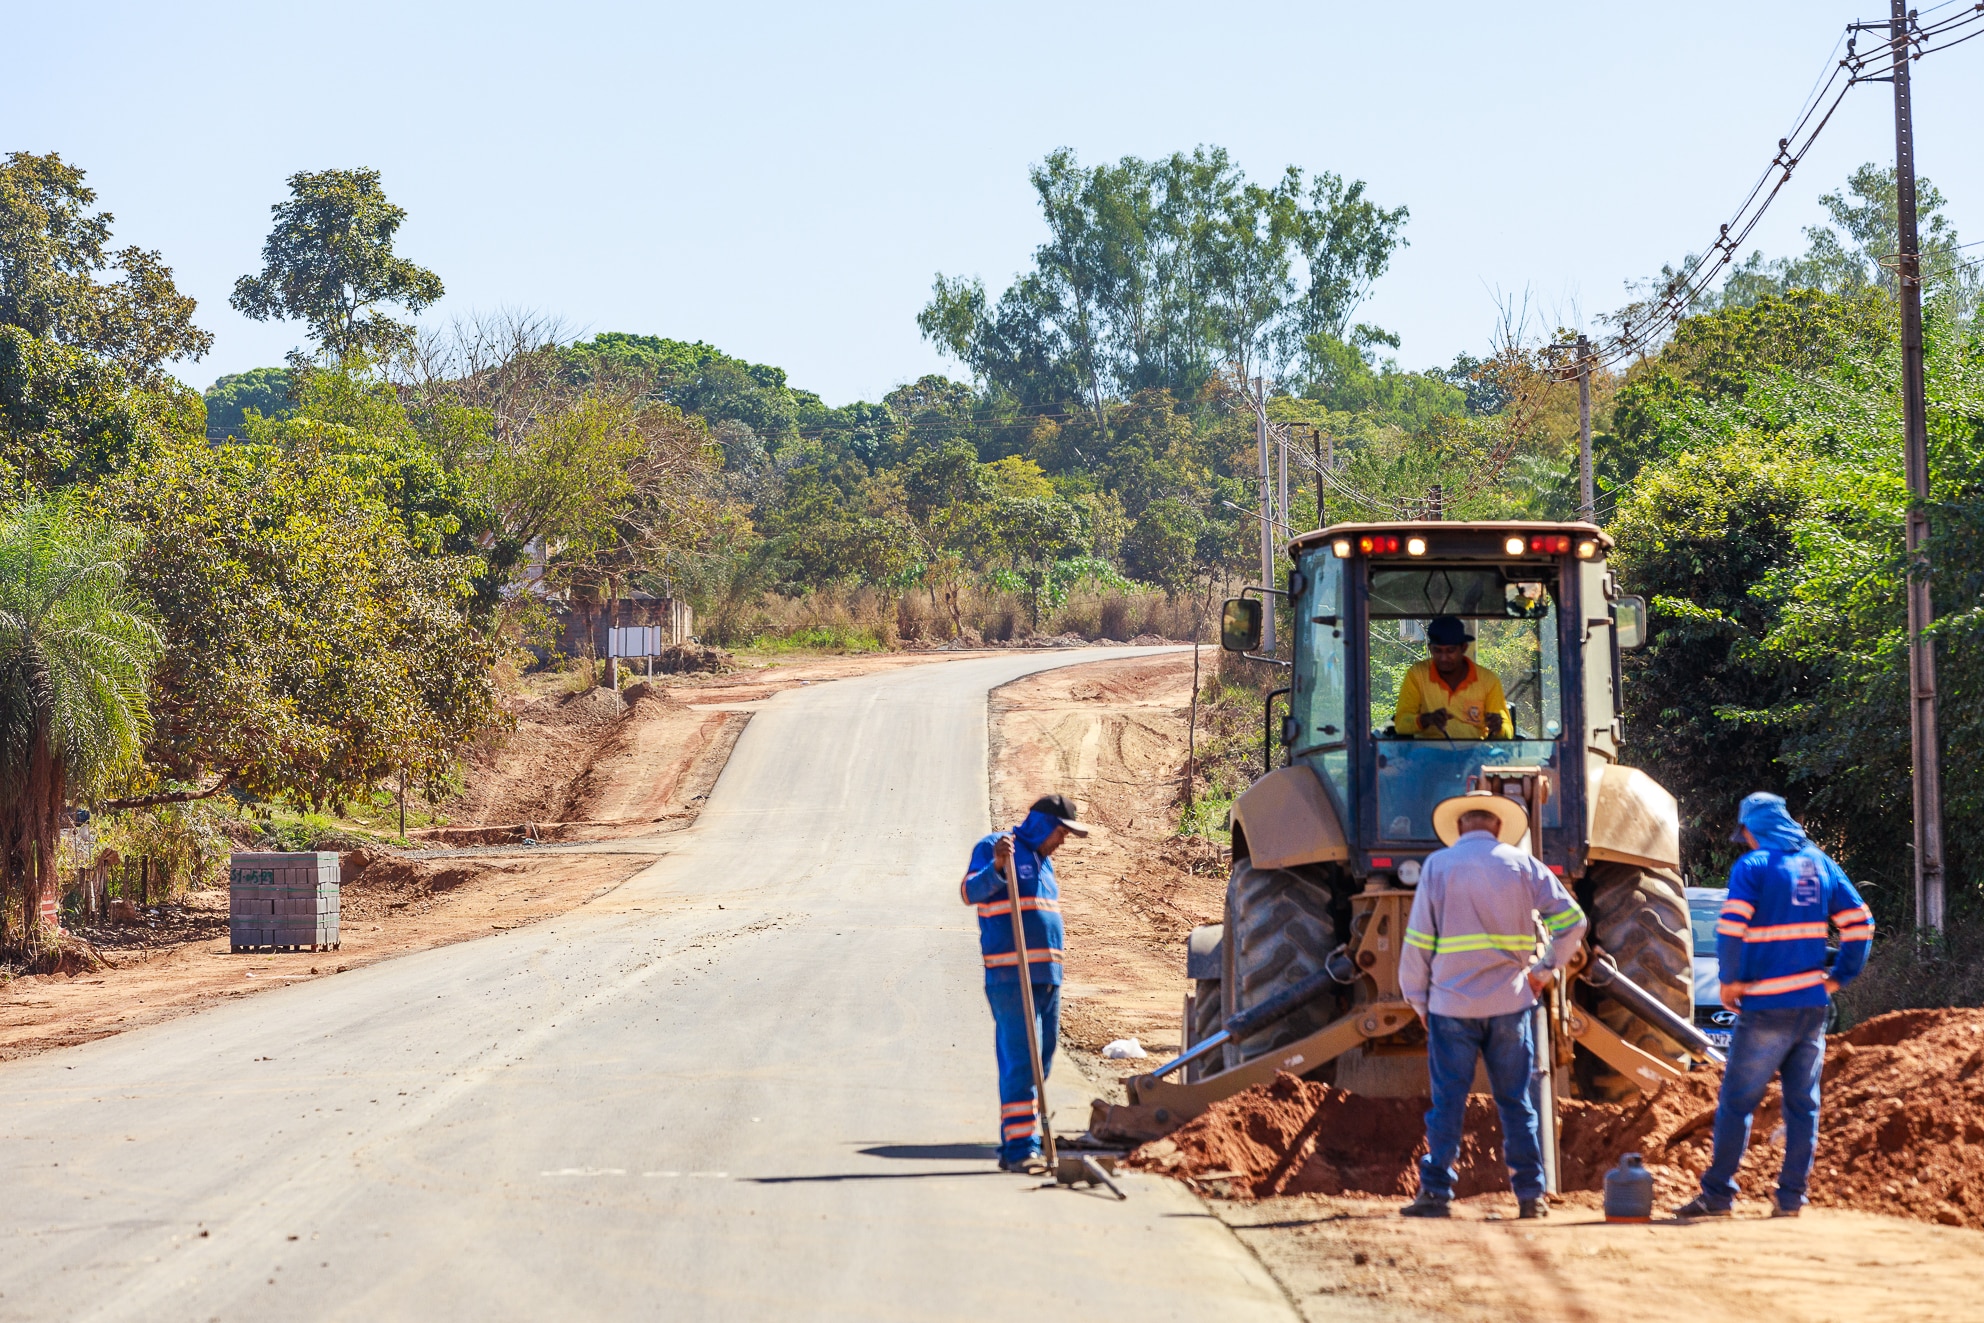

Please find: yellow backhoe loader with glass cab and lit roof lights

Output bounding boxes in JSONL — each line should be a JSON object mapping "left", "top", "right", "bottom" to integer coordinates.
{"left": 1091, "top": 522, "right": 1720, "bottom": 1141}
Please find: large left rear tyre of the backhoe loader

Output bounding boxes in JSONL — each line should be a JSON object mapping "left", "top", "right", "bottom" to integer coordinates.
{"left": 1220, "top": 855, "right": 1343, "bottom": 1067}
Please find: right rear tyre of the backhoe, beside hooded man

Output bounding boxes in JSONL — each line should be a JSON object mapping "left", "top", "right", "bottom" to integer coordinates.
{"left": 1585, "top": 861, "right": 1694, "bottom": 1099}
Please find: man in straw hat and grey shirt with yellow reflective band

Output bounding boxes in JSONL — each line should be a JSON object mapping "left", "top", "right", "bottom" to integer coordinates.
{"left": 1399, "top": 789, "right": 1585, "bottom": 1218}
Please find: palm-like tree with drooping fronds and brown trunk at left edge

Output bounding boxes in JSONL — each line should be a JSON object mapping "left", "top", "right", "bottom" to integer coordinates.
{"left": 0, "top": 502, "right": 161, "bottom": 960}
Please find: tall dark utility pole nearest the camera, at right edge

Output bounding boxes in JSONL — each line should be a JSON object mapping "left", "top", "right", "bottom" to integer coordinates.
{"left": 1889, "top": 0, "right": 1942, "bottom": 932}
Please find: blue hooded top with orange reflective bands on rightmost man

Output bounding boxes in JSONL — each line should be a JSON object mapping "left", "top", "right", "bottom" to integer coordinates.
{"left": 1716, "top": 793, "right": 1873, "bottom": 1010}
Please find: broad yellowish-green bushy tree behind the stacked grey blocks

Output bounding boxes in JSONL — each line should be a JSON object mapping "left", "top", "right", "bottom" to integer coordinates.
{"left": 101, "top": 434, "right": 498, "bottom": 807}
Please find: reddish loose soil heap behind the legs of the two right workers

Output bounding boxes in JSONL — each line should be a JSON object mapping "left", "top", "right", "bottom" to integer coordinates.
{"left": 1129, "top": 1010, "right": 1984, "bottom": 1228}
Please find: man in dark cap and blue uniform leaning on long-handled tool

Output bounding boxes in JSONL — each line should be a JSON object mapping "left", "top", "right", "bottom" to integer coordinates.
{"left": 958, "top": 795, "right": 1089, "bottom": 1172}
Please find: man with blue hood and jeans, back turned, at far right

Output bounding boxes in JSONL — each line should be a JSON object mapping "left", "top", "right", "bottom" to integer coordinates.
{"left": 1674, "top": 791, "right": 1873, "bottom": 1218}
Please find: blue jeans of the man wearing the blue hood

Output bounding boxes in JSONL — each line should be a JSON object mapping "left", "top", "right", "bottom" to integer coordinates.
{"left": 1702, "top": 1006, "right": 1825, "bottom": 1208}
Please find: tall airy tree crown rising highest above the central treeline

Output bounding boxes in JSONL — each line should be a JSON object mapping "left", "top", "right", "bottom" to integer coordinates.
{"left": 917, "top": 147, "right": 1407, "bottom": 408}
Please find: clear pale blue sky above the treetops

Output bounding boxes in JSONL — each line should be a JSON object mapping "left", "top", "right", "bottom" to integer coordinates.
{"left": 0, "top": 0, "right": 1984, "bottom": 405}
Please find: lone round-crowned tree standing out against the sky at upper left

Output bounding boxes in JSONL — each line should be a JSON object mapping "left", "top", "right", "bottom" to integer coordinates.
{"left": 228, "top": 169, "right": 442, "bottom": 359}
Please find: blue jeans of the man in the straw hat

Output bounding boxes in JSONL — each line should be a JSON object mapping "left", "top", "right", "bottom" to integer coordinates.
{"left": 1419, "top": 1012, "right": 1544, "bottom": 1198}
